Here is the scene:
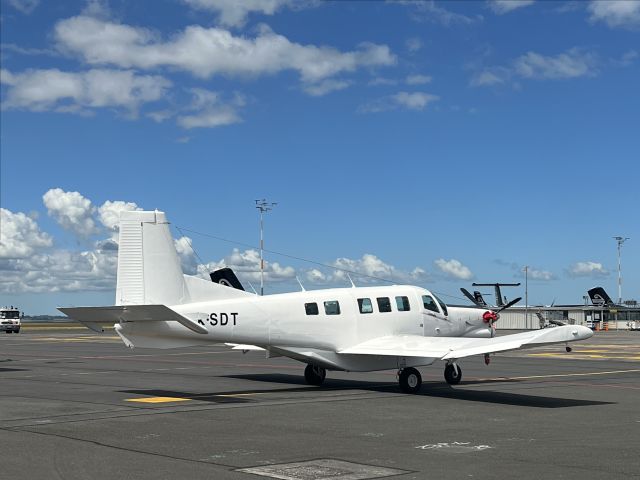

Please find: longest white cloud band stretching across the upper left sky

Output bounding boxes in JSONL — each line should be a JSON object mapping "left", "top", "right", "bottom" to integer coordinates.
{"left": 54, "top": 15, "right": 396, "bottom": 83}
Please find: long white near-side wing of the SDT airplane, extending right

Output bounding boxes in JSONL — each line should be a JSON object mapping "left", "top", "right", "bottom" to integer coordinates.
{"left": 338, "top": 325, "right": 593, "bottom": 360}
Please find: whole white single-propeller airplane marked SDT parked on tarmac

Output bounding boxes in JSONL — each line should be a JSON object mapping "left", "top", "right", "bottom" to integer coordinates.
{"left": 59, "top": 211, "right": 593, "bottom": 393}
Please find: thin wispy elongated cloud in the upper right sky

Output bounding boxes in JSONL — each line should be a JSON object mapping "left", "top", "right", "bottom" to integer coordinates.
{"left": 469, "top": 48, "right": 598, "bottom": 87}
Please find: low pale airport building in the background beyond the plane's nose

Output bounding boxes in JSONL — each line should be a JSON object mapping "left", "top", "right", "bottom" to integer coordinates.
{"left": 497, "top": 301, "right": 640, "bottom": 330}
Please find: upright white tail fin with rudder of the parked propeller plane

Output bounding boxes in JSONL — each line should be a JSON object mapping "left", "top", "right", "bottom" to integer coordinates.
{"left": 116, "top": 211, "right": 189, "bottom": 305}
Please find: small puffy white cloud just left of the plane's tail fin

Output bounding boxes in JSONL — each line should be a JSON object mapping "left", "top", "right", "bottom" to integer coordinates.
{"left": 42, "top": 188, "right": 97, "bottom": 237}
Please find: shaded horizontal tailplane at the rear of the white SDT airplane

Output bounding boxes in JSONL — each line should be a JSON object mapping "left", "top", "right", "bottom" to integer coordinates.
{"left": 58, "top": 305, "right": 208, "bottom": 334}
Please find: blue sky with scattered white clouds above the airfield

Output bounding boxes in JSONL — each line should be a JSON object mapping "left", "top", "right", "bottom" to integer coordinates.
{"left": 0, "top": 0, "right": 640, "bottom": 314}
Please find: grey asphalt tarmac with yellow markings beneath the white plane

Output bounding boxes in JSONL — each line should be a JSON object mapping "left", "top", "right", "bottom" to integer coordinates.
{"left": 0, "top": 325, "right": 640, "bottom": 480}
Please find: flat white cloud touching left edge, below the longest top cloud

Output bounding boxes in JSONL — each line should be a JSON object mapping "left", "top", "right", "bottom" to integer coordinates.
{"left": 1, "top": 69, "right": 171, "bottom": 114}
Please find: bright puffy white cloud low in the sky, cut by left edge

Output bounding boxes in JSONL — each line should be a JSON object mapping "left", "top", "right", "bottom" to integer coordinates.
{"left": 0, "top": 208, "right": 53, "bottom": 258}
